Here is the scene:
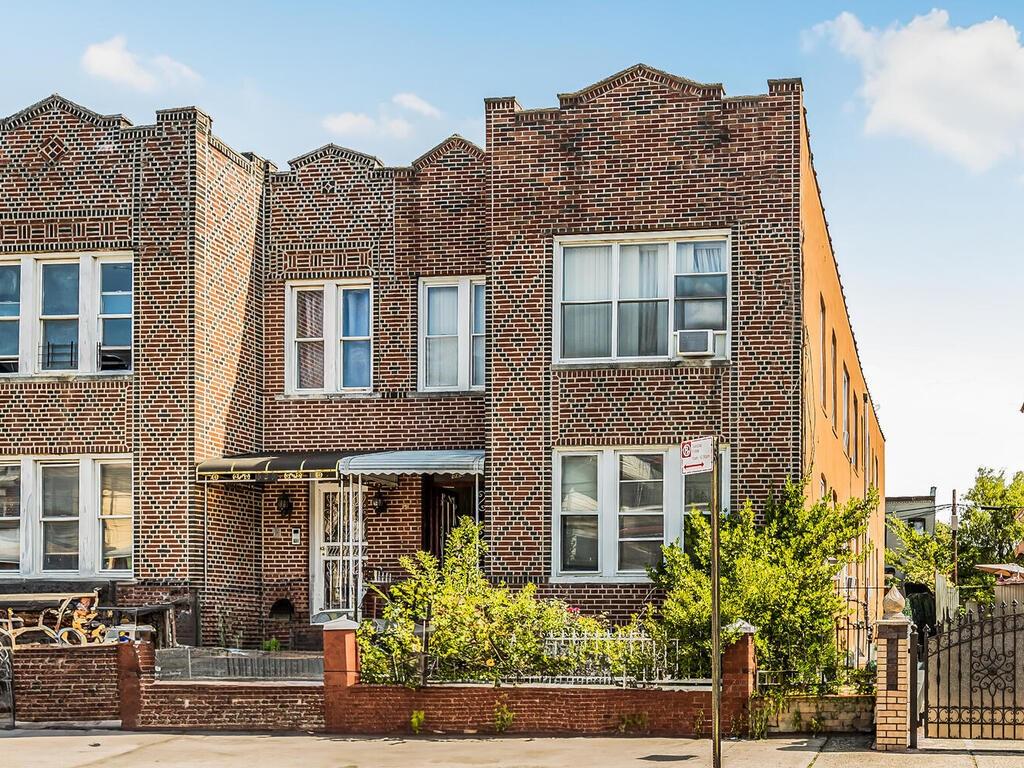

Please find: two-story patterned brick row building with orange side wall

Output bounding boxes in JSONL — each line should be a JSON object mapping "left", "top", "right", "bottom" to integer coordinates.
{"left": 0, "top": 66, "right": 885, "bottom": 644}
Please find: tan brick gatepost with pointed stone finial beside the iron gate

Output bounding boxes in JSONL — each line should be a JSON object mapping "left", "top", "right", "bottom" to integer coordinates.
{"left": 874, "top": 587, "right": 916, "bottom": 752}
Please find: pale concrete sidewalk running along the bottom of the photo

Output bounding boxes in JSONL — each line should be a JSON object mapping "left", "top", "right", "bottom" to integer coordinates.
{"left": 0, "top": 730, "right": 1024, "bottom": 768}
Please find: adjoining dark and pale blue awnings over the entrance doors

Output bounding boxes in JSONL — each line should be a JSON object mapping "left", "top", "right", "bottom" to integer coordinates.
{"left": 196, "top": 450, "right": 483, "bottom": 482}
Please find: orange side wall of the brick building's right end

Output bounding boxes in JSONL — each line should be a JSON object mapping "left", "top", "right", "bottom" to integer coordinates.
{"left": 800, "top": 109, "right": 886, "bottom": 651}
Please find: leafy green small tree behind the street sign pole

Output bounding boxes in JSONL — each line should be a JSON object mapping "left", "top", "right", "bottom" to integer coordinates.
{"left": 651, "top": 482, "right": 878, "bottom": 677}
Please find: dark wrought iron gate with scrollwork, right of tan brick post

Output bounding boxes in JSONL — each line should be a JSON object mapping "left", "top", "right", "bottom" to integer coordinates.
{"left": 924, "top": 603, "right": 1024, "bottom": 739}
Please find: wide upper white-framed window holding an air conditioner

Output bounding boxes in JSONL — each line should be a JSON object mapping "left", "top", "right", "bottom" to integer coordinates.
{"left": 552, "top": 230, "right": 731, "bottom": 362}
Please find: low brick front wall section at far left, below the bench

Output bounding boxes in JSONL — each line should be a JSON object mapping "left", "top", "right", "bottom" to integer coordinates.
{"left": 13, "top": 645, "right": 120, "bottom": 723}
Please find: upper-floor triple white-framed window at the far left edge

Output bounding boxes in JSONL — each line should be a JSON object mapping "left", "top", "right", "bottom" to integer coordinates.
{"left": 0, "top": 252, "right": 134, "bottom": 376}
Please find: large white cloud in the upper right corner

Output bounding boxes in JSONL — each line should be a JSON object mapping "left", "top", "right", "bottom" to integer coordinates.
{"left": 804, "top": 10, "right": 1024, "bottom": 171}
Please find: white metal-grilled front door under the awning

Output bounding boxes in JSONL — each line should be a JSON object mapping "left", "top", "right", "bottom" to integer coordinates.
{"left": 310, "top": 480, "right": 367, "bottom": 621}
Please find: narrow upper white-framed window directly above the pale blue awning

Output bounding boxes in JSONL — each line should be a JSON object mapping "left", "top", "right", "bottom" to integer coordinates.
{"left": 418, "top": 276, "right": 486, "bottom": 392}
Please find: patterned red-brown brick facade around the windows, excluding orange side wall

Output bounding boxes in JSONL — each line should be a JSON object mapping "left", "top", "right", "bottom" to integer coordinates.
{"left": 0, "top": 66, "right": 880, "bottom": 645}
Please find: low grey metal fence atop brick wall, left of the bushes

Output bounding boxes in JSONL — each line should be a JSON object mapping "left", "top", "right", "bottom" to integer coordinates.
{"left": 157, "top": 647, "right": 324, "bottom": 680}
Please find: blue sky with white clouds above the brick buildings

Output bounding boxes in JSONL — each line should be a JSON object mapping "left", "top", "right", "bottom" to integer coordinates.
{"left": 0, "top": 0, "right": 1024, "bottom": 501}
